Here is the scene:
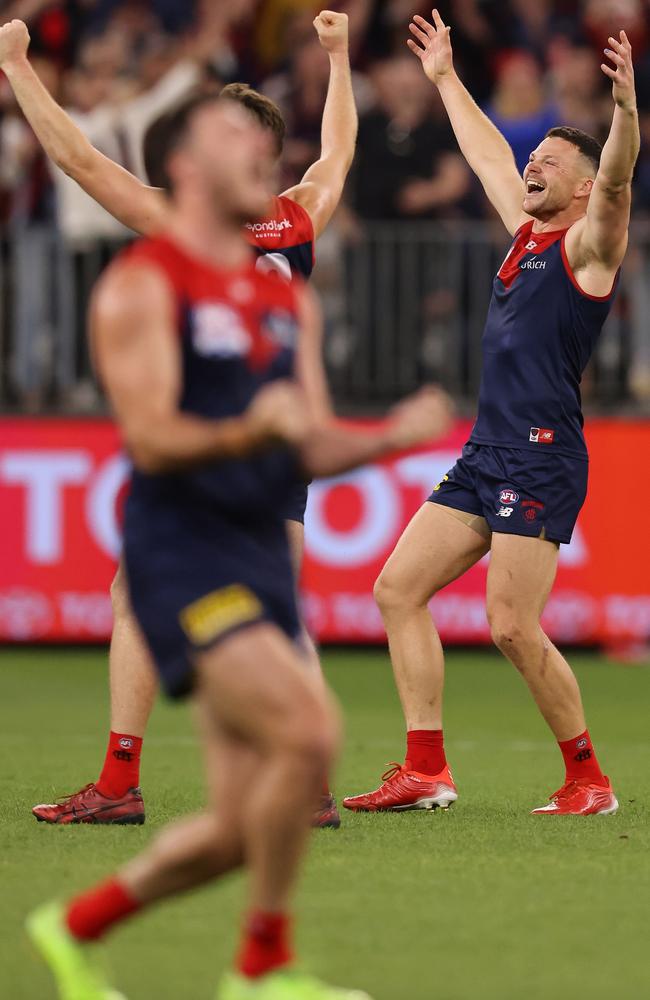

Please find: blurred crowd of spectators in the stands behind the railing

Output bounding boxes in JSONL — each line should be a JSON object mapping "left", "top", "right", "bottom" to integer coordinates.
{"left": 0, "top": 0, "right": 650, "bottom": 410}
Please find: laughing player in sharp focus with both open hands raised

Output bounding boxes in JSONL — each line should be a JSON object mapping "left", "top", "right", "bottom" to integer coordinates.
{"left": 344, "top": 10, "right": 639, "bottom": 815}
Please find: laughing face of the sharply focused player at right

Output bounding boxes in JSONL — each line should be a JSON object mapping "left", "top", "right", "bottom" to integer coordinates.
{"left": 522, "top": 137, "right": 591, "bottom": 220}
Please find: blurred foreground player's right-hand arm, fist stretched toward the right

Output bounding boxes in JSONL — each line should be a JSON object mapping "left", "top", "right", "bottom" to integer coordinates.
{"left": 296, "top": 286, "right": 453, "bottom": 476}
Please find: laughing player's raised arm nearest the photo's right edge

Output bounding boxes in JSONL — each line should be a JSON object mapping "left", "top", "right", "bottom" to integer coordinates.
{"left": 566, "top": 31, "right": 640, "bottom": 282}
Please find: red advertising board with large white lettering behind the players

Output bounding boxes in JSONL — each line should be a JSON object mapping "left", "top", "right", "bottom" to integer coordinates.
{"left": 0, "top": 420, "right": 650, "bottom": 643}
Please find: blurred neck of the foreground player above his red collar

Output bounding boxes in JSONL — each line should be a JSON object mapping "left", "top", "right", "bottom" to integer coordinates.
{"left": 167, "top": 204, "right": 250, "bottom": 268}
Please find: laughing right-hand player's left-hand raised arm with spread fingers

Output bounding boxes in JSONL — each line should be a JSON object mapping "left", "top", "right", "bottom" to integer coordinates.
{"left": 407, "top": 10, "right": 528, "bottom": 233}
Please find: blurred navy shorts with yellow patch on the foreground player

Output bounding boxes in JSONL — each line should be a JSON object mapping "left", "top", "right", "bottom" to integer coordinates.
{"left": 124, "top": 497, "right": 300, "bottom": 698}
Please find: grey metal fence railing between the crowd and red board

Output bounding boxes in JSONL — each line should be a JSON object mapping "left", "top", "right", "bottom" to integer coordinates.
{"left": 0, "top": 222, "right": 650, "bottom": 412}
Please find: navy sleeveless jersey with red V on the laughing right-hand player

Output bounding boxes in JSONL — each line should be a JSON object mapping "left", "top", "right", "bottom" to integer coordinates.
{"left": 470, "top": 220, "right": 616, "bottom": 458}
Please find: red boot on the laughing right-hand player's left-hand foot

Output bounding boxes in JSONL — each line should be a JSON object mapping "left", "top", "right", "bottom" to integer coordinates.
{"left": 343, "top": 760, "right": 458, "bottom": 812}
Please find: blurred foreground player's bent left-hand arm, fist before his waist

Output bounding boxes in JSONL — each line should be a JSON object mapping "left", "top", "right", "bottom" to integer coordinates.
{"left": 91, "top": 264, "right": 307, "bottom": 473}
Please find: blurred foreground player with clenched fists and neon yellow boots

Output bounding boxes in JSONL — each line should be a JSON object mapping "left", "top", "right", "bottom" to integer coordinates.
{"left": 28, "top": 97, "right": 450, "bottom": 1000}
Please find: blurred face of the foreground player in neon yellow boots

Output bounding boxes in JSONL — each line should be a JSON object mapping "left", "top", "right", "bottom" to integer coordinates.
{"left": 187, "top": 101, "right": 275, "bottom": 222}
